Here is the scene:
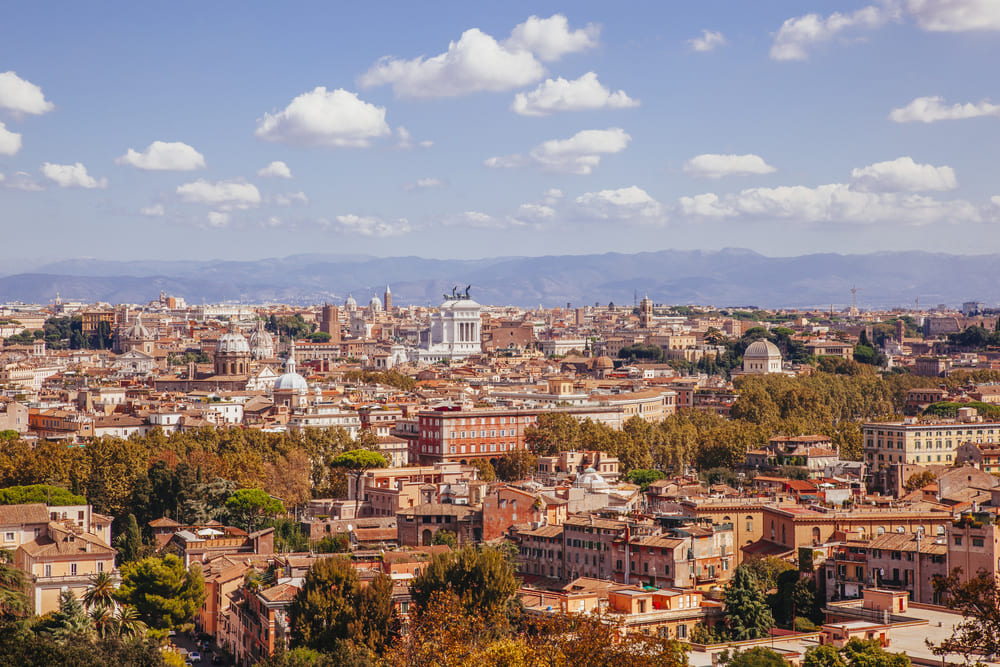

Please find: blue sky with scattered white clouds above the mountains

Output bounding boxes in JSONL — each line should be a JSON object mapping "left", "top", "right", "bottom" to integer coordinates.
{"left": 0, "top": 0, "right": 1000, "bottom": 264}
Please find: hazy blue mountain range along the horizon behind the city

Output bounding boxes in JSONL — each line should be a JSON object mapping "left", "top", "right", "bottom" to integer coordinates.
{"left": 0, "top": 249, "right": 1000, "bottom": 308}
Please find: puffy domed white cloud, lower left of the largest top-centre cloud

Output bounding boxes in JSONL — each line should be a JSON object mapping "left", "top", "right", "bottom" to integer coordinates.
{"left": 254, "top": 86, "right": 392, "bottom": 147}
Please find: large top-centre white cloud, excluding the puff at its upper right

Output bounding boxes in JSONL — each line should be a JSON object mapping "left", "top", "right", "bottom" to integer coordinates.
{"left": 360, "top": 28, "right": 545, "bottom": 98}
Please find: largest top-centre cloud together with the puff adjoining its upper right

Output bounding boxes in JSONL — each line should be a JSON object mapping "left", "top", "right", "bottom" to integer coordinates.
{"left": 359, "top": 14, "right": 600, "bottom": 98}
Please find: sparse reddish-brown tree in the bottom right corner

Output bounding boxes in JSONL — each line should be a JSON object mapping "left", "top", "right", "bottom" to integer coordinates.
{"left": 931, "top": 568, "right": 1000, "bottom": 662}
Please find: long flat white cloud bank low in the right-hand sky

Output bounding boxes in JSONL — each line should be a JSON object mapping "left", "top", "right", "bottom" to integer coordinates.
{"left": 679, "top": 183, "right": 982, "bottom": 225}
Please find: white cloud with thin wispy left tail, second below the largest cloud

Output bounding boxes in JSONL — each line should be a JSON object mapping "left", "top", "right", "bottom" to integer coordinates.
{"left": 484, "top": 127, "right": 632, "bottom": 175}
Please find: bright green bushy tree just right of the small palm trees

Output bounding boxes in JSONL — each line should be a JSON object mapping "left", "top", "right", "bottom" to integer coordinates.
{"left": 115, "top": 554, "right": 205, "bottom": 631}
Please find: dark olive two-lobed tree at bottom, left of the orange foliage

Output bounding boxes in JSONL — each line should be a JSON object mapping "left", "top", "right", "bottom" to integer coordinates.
{"left": 289, "top": 557, "right": 397, "bottom": 654}
